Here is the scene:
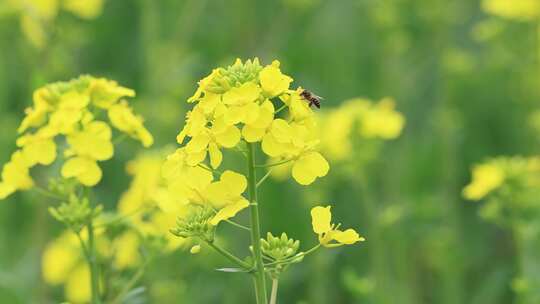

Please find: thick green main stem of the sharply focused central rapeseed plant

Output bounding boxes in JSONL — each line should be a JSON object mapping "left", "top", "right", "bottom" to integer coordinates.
{"left": 247, "top": 143, "right": 268, "bottom": 304}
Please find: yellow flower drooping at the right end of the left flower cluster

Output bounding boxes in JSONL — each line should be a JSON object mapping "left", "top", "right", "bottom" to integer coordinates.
{"left": 108, "top": 100, "right": 154, "bottom": 147}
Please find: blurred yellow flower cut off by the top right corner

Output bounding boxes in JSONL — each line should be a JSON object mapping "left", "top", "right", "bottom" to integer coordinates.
{"left": 482, "top": 0, "right": 540, "bottom": 21}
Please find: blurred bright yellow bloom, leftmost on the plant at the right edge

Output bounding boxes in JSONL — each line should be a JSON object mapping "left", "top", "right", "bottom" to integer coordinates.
{"left": 463, "top": 163, "right": 505, "bottom": 201}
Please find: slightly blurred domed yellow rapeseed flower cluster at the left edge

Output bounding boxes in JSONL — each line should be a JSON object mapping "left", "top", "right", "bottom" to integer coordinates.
{"left": 0, "top": 76, "right": 153, "bottom": 199}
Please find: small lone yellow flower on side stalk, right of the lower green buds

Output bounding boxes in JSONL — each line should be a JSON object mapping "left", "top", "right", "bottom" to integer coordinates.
{"left": 311, "top": 206, "right": 365, "bottom": 247}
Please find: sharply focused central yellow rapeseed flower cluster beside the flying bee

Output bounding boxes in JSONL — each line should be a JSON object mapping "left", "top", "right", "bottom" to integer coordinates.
{"left": 162, "top": 59, "right": 329, "bottom": 230}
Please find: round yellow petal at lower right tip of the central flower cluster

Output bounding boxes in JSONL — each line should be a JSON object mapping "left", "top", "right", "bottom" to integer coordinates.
{"left": 292, "top": 152, "right": 330, "bottom": 185}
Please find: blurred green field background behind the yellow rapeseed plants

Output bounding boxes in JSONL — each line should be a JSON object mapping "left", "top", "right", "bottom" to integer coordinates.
{"left": 0, "top": 0, "right": 540, "bottom": 304}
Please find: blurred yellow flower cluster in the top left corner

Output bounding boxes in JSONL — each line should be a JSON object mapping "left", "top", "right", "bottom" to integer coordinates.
{"left": 7, "top": 0, "right": 104, "bottom": 48}
